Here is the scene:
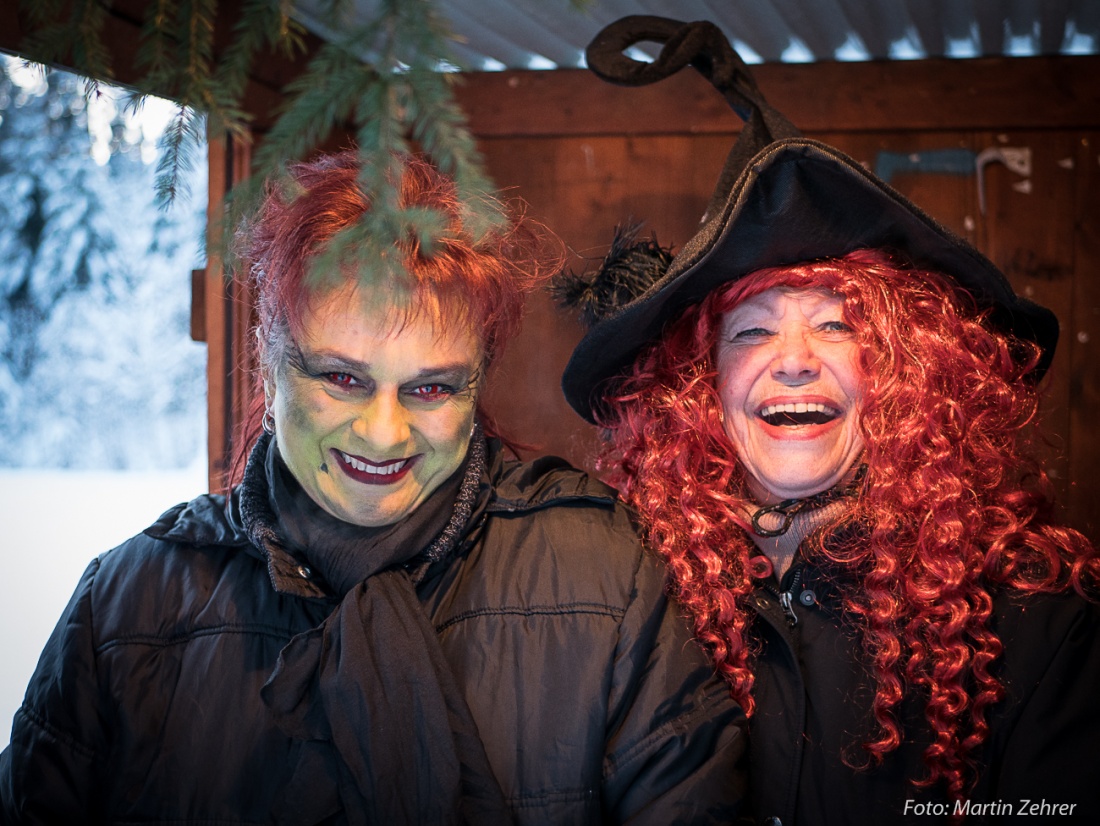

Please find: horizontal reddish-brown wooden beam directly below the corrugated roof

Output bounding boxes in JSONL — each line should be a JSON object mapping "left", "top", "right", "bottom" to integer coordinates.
{"left": 455, "top": 55, "right": 1100, "bottom": 137}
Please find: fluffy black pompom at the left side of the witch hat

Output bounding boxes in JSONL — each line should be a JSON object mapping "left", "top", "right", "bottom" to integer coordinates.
{"left": 550, "top": 221, "right": 674, "bottom": 328}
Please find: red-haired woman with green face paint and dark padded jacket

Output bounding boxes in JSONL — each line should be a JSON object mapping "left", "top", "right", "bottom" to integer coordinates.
{"left": 0, "top": 153, "right": 744, "bottom": 825}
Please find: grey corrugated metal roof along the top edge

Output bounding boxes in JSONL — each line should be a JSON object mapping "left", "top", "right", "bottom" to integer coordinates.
{"left": 298, "top": 0, "right": 1100, "bottom": 70}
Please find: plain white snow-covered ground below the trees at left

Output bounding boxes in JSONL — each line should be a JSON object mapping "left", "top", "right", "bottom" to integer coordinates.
{"left": 0, "top": 466, "right": 207, "bottom": 749}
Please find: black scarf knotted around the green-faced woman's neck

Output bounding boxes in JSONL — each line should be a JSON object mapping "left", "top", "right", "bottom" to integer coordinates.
{"left": 242, "top": 431, "right": 512, "bottom": 826}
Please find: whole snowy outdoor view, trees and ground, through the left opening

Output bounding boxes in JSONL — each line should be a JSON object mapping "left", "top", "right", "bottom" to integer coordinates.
{"left": 0, "top": 55, "right": 207, "bottom": 748}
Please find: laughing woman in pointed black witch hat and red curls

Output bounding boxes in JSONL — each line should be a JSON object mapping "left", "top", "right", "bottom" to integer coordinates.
{"left": 563, "top": 18, "right": 1100, "bottom": 826}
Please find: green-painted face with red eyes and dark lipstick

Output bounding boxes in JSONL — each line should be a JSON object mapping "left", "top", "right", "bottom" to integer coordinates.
{"left": 264, "top": 286, "right": 483, "bottom": 527}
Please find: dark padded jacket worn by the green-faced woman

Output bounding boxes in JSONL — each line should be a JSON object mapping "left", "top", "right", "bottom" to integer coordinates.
{"left": 0, "top": 445, "right": 746, "bottom": 826}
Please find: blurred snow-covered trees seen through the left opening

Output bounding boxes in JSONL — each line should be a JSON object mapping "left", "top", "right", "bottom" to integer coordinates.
{"left": 0, "top": 55, "right": 206, "bottom": 470}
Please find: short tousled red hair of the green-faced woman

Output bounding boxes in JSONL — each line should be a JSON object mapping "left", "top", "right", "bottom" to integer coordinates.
{"left": 228, "top": 150, "right": 563, "bottom": 484}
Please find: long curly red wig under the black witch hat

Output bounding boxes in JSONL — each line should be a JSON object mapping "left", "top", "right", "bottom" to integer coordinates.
{"left": 601, "top": 251, "right": 1100, "bottom": 799}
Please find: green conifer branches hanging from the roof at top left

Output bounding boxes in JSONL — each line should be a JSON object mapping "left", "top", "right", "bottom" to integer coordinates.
{"left": 12, "top": 0, "right": 517, "bottom": 268}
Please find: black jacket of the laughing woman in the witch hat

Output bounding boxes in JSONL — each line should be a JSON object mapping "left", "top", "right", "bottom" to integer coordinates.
{"left": 746, "top": 561, "right": 1100, "bottom": 826}
